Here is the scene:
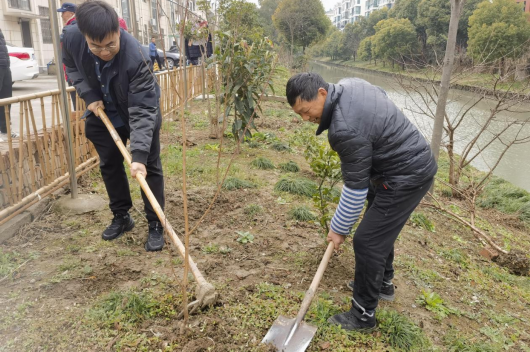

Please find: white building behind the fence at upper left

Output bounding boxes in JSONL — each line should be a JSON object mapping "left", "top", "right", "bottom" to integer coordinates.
{"left": 0, "top": 0, "right": 202, "bottom": 72}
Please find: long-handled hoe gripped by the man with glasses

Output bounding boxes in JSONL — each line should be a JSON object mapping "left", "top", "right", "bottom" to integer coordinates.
{"left": 98, "top": 108, "right": 217, "bottom": 314}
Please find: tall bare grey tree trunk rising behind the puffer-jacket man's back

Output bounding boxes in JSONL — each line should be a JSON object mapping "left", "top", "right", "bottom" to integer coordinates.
{"left": 431, "top": 0, "right": 466, "bottom": 193}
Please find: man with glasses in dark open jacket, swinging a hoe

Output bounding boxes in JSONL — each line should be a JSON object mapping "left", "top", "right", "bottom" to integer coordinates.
{"left": 63, "top": 1, "right": 164, "bottom": 251}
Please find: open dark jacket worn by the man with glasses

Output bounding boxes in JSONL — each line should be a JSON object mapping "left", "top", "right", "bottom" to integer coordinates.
{"left": 63, "top": 25, "right": 162, "bottom": 165}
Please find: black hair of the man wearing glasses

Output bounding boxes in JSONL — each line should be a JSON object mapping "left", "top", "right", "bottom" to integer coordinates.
{"left": 75, "top": 0, "right": 120, "bottom": 42}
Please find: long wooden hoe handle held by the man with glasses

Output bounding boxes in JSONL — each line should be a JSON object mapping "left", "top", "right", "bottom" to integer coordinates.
{"left": 98, "top": 108, "right": 208, "bottom": 286}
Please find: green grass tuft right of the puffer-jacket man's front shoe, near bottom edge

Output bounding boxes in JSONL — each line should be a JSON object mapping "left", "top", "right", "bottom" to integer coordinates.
{"left": 376, "top": 309, "right": 430, "bottom": 351}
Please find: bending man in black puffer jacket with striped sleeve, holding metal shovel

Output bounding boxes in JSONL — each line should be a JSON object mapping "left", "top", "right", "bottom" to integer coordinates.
{"left": 287, "top": 73, "right": 437, "bottom": 330}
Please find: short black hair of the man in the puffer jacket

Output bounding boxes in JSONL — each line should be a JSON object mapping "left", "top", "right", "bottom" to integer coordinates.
{"left": 285, "top": 72, "right": 329, "bottom": 106}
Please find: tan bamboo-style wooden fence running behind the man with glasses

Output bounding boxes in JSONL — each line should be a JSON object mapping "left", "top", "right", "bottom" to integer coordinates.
{"left": 0, "top": 66, "right": 211, "bottom": 220}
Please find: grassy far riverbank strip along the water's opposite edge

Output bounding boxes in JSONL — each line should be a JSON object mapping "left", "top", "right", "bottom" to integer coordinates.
{"left": 314, "top": 58, "right": 530, "bottom": 100}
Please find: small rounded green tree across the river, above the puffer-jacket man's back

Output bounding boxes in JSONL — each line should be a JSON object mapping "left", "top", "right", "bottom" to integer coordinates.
{"left": 371, "top": 18, "right": 418, "bottom": 66}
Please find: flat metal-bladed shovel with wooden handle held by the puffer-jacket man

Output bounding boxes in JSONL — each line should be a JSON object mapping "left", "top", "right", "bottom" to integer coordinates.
{"left": 261, "top": 242, "right": 334, "bottom": 352}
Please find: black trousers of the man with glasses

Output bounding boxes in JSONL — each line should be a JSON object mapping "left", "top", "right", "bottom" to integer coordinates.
{"left": 86, "top": 114, "right": 165, "bottom": 222}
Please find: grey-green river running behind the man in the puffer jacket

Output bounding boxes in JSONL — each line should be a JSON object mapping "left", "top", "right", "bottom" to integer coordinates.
{"left": 310, "top": 62, "right": 530, "bottom": 191}
